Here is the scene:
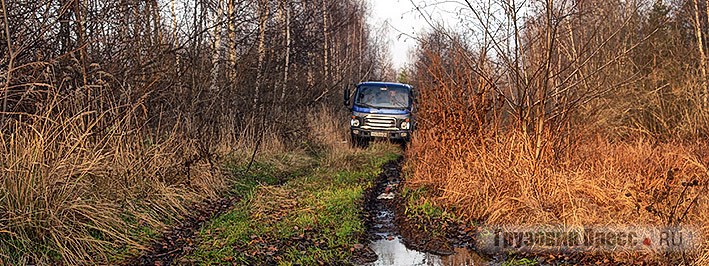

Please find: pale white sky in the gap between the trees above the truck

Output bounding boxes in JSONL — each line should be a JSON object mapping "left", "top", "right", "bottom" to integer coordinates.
{"left": 368, "top": 0, "right": 460, "bottom": 69}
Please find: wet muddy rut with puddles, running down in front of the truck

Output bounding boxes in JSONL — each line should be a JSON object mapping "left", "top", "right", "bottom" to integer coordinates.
{"left": 356, "top": 158, "right": 488, "bottom": 266}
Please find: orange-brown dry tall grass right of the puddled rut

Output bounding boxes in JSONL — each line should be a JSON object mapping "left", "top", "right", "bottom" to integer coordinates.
{"left": 408, "top": 133, "right": 709, "bottom": 225}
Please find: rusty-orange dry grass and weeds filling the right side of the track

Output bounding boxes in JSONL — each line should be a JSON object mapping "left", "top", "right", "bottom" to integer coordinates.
{"left": 405, "top": 75, "right": 709, "bottom": 265}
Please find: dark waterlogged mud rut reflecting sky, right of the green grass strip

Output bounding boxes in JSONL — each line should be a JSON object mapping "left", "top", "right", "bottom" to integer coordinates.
{"left": 354, "top": 158, "right": 488, "bottom": 265}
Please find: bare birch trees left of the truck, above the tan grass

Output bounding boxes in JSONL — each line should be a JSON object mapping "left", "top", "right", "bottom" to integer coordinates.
{"left": 0, "top": 0, "right": 381, "bottom": 143}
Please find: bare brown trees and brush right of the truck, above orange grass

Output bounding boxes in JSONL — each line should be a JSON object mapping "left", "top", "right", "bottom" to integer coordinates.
{"left": 409, "top": 0, "right": 709, "bottom": 153}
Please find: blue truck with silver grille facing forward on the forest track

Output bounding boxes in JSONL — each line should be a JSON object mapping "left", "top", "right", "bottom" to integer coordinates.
{"left": 344, "top": 82, "right": 415, "bottom": 146}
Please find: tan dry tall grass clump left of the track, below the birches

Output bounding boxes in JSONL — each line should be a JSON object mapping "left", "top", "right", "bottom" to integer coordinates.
{"left": 0, "top": 91, "right": 232, "bottom": 265}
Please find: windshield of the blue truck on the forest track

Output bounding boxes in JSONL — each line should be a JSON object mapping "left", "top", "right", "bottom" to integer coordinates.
{"left": 355, "top": 86, "right": 409, "bottom": 109}
